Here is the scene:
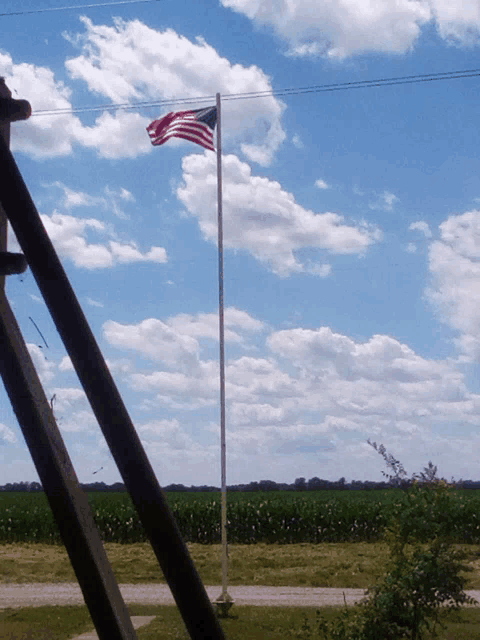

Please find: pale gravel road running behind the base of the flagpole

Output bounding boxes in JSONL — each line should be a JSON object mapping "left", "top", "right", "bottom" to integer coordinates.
{"left": 0, "top": 582, "right": 480, "bottom": 609}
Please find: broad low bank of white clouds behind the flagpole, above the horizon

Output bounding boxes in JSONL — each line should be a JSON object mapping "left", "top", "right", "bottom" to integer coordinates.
{"left": 95, "top": 302, "right": 480, "bottom": 475}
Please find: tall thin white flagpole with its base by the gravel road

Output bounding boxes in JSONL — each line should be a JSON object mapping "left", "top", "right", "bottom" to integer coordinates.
{"left": 216, "top": 93, "right": 233, "bottom": 615}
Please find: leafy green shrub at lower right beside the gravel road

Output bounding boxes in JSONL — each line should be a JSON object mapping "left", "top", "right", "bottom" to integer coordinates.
{"left": 301, "top": 444, "right": 476, "bottom": 640}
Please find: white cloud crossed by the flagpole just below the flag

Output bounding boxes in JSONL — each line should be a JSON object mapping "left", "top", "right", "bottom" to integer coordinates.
{"left": 177, "top": 153, "right": 381, "bottom": 276}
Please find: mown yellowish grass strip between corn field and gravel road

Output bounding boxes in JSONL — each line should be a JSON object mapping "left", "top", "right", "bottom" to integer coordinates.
{"left": 0, "top": 542, "right": 480, "bottom": 589}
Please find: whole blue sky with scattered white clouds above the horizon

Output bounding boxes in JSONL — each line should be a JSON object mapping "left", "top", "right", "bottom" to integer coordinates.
{"left": 0, "top": 0, "right": 480, "bottom": 485}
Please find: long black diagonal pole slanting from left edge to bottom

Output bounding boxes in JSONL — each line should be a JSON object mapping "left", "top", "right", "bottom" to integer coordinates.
{"left": 0, "top": 109, "right": 225, "bottom": 640}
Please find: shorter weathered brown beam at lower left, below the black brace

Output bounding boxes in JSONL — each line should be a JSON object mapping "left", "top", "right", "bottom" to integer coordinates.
{"left": 0, "top": 292, "right": 137, "bottom": 640}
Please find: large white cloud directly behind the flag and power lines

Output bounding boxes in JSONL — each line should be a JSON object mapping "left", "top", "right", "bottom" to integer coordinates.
{"left": 66, "top": 17, "right": 285, "bottom": 164}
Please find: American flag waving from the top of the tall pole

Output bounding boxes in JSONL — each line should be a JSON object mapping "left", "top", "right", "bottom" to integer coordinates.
{"left": 147, "top": 107, "right": 217, "bottom": 151}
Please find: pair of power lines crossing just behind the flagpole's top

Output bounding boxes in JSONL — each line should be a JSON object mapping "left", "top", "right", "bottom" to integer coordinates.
{"left": 32, "top": 69, "right": 480, "bottom": 117}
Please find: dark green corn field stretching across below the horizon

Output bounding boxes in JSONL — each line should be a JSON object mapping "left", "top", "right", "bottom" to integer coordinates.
{"left": 0, "top": 490, "right": 480, "bottom": 544}
